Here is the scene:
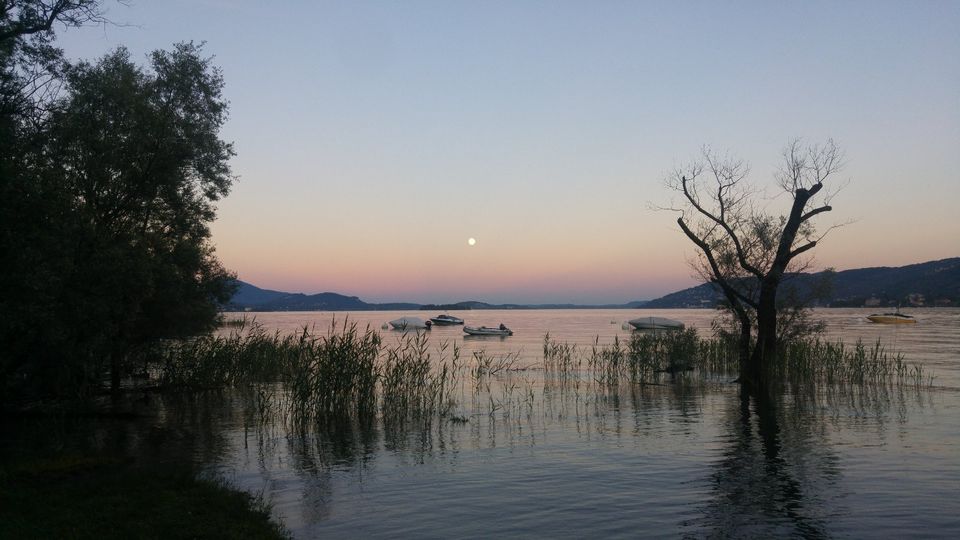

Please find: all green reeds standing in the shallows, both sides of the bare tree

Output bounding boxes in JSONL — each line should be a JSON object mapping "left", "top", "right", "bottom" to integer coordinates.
{"left": 142, "top": 320, "right": 932, "bottom": 426}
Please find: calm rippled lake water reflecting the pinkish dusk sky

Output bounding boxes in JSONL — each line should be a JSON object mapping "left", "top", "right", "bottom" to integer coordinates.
{"left": 201, "top": 309, "right": 960, "bottom": 538}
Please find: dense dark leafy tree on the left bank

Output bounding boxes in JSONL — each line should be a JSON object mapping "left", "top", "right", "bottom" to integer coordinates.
{"left": 0, "top": 1, "right": 233, "bottom": 400}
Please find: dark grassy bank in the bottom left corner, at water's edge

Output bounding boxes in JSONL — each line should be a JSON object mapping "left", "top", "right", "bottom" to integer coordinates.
{"left": 0, "top": 454, "right": 289, "bottom": 538}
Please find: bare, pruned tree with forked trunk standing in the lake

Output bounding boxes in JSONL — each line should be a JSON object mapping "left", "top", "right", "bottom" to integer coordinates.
{"left": 667, "top": 140, "right": 842, "bottom": 384}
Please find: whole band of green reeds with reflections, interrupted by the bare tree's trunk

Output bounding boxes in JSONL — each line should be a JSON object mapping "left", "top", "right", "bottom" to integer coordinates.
{"left": 149, "top": 320, "right": 931, "bottom": 452}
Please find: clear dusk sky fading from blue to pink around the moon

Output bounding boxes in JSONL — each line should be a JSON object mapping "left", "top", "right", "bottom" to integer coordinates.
{"left": 58, "top": 0, "right": 960, "bottom": 304}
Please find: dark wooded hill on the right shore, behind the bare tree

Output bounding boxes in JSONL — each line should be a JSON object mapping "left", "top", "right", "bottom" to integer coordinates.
{"left": 642, "top": 257, "right": 960, "bottom": 309}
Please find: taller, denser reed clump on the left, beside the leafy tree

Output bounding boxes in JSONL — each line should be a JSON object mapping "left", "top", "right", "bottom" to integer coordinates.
{"left": 154, "top": 320, "right": 466, "bottom": 421}
